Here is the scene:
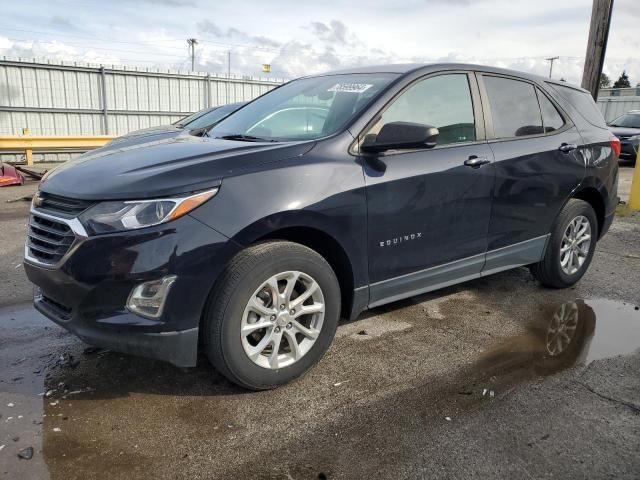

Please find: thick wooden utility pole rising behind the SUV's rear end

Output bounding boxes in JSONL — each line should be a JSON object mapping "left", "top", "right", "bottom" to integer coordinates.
{"left": 582, "top": 0, "right": 613, "bottom": 100}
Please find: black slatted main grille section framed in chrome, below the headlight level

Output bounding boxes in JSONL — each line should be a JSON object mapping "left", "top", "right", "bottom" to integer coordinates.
{"left": 27, "top": 213, "right": 75, "bottom": 265}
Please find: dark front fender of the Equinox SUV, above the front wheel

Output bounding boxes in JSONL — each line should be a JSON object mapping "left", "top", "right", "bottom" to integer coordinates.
{"left": 191, "top": 153, "right": 368, "bottom": 286}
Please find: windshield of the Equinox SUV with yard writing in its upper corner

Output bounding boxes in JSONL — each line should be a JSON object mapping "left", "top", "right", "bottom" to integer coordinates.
{"left": 209, "top": 73, "right": 398, "bottom": 141}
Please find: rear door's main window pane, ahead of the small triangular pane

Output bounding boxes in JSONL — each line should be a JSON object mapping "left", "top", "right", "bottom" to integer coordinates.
{"left": 482, "top": 75, "right": 544, "bottom": 138}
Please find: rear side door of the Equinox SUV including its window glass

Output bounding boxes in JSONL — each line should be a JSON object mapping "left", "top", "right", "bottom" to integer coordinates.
{"left": 478, "top": 73, "right": 585, "bottom": 274}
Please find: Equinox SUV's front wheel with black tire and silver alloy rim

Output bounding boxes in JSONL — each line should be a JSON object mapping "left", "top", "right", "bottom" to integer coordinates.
{"left": 203, "top": 241, "right": 340, "bottom": 390}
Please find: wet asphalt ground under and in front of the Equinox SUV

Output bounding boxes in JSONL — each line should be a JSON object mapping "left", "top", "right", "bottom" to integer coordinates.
{"left": 0, "top": 172, "right": 640, "bottom": 479}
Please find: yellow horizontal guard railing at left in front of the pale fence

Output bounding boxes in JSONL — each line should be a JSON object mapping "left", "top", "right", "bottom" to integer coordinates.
{"left": 0, "top": 128, "right": 115, "bottom": 165}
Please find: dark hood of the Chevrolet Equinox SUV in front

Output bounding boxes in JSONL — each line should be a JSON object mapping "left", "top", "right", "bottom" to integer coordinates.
{"left": 40, "top": 135, "right": 315, "bottom": 200}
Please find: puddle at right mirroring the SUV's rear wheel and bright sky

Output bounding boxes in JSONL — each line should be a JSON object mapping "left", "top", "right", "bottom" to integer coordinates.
{"left": 478, "top": 299, "right": 640, "bottom": 375}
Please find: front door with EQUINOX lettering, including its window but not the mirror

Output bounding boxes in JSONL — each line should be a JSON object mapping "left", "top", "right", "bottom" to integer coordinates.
{"left": 362, "top": 72, "right": 494, "bottom": 306}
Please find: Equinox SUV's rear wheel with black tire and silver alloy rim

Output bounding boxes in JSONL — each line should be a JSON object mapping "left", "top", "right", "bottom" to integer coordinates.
{"left": 530, "top": 198, "right": 598, "bottom": 288}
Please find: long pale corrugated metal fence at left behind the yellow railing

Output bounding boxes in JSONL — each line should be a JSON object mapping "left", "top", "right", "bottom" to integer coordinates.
{"left": 0, "top": 57, "right": 284, "bottom": 161}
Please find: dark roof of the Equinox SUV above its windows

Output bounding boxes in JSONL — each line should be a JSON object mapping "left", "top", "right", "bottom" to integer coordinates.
{"left": 309, "top": 63, "right": 589, "bottom": 93}
